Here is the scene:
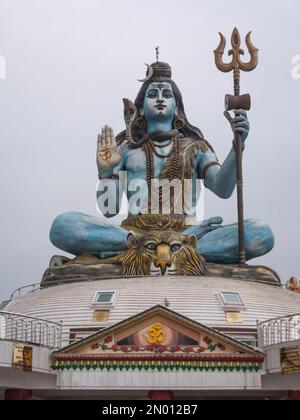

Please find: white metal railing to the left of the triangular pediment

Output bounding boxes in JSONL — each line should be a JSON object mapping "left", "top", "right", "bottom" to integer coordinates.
{"left": 0, "top": 311, "right": 62, "bottom": 349}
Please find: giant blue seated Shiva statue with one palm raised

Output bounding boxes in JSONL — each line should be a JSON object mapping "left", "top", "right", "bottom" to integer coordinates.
{"left": 50, "top": 61, "right": 274, "bottom": 264}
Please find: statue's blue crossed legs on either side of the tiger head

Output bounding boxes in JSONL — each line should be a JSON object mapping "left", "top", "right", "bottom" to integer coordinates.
{"left": 50, "top": 212, "right": 274, "bottom": 264}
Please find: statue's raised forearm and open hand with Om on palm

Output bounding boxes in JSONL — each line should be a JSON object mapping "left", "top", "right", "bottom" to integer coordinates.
{"left": 97, "top": 126, "right": 127, "bottom": 218}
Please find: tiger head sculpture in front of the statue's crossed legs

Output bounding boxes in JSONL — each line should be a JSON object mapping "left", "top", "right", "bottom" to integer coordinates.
{"left": 118, "top": 231, "right": 206, "bottom": 276}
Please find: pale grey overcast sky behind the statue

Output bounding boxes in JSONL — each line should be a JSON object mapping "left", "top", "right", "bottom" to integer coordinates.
{"left": 0, "top": 0, "right": 300, "bottom": 299}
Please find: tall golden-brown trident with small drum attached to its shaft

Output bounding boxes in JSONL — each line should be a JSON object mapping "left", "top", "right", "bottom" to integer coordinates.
{"left": 214, "top": 28, "right": 258, "bottom": 266}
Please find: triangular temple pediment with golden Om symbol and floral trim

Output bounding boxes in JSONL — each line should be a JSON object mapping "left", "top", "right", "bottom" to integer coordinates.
{"left": 53, "top": 306, "right": 264, "bottom": 370}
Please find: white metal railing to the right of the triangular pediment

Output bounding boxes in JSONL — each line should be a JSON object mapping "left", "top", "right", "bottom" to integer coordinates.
{"left": 257, "top": 314, "right": 300, "bottom": 347}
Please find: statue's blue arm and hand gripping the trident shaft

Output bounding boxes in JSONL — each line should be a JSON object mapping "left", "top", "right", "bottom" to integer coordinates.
{"left": 199, "top": 110, "right": 250, "bottom": 199}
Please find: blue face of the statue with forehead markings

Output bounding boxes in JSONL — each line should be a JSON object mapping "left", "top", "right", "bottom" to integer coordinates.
{"left": 144, "top": 82, "right": 176, "bottom": 121}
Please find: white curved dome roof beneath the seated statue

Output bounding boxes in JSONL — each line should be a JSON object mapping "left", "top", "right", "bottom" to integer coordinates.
{"left": 5, "top": 276, "right": 300, "bottom": 329}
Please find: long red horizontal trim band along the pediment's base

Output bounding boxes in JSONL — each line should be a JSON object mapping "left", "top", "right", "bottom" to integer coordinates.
{"left": 53, "top": 354, "right": 265, "bottom": 363}
